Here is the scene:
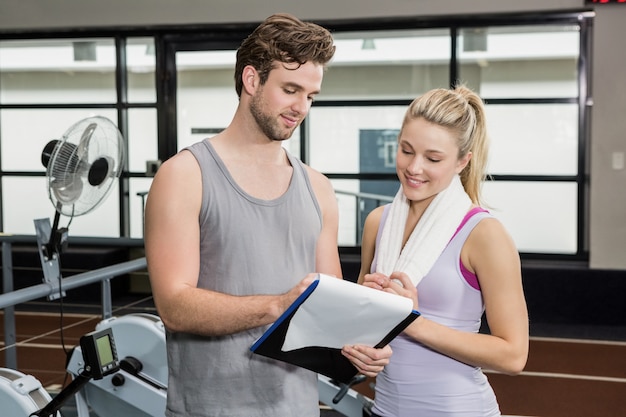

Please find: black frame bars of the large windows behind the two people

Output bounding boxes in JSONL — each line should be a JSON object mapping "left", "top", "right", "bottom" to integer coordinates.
{"left": 0, "top": 10, "right": 594, "bottom": 261}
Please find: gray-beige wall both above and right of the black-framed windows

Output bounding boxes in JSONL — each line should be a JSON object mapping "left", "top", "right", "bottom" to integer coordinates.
{"left": 0, "top": 0, "right": 626, "bottom": 269}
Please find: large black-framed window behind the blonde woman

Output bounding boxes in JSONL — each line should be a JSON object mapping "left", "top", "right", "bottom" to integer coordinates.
{"left": 306, "top": 17, "right": 588, "bottom": 256}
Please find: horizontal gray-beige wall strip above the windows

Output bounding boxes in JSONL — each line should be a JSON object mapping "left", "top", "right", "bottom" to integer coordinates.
{"left": 0, "top": 0, "right": 584, "bottom": 30}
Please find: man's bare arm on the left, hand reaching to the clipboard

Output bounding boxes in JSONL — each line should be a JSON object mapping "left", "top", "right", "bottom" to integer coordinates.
{"left": 145, "top": 151, "right": 310, "bottom": 335}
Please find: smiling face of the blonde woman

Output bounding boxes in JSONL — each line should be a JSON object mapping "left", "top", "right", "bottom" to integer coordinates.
{"left": 396, "top": 118, "right": 471, "bottom": 202}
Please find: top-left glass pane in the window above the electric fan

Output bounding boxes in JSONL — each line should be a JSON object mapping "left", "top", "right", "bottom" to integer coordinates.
{"left": 0, "top": 39, "right": 117, "bottom": 104}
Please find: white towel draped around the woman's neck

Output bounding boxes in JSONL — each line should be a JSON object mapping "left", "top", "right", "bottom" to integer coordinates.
{"left": 376, "top": 175, "right": 472, "bottom": 286}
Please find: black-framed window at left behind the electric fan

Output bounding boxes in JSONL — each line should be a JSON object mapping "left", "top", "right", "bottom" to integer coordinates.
{"left": 0, "top": 36, "right": 158, "bottom": 237}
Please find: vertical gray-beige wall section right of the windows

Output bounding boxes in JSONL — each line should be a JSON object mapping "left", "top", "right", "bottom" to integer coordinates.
{"left": 590, "top": 4, "right": 626, "bottom": 269}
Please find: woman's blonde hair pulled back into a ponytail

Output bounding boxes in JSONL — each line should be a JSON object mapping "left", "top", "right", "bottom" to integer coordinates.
{"left": 400, "top": 84, "right": 489, "bottom": 205}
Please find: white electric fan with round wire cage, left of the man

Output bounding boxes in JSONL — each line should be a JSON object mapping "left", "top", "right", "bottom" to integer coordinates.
{"left": 36, "top": 116, "right": 125, "bottom": 259}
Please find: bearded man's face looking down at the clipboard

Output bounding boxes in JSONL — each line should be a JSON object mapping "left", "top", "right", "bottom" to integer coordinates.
{"left": 250, "top": 62, "right": 324, "bottom": 141}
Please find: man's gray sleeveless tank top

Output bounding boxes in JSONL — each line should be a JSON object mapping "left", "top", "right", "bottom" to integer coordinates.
{"left": 166, "top": 140, "right": 322, "bottom": 417}
